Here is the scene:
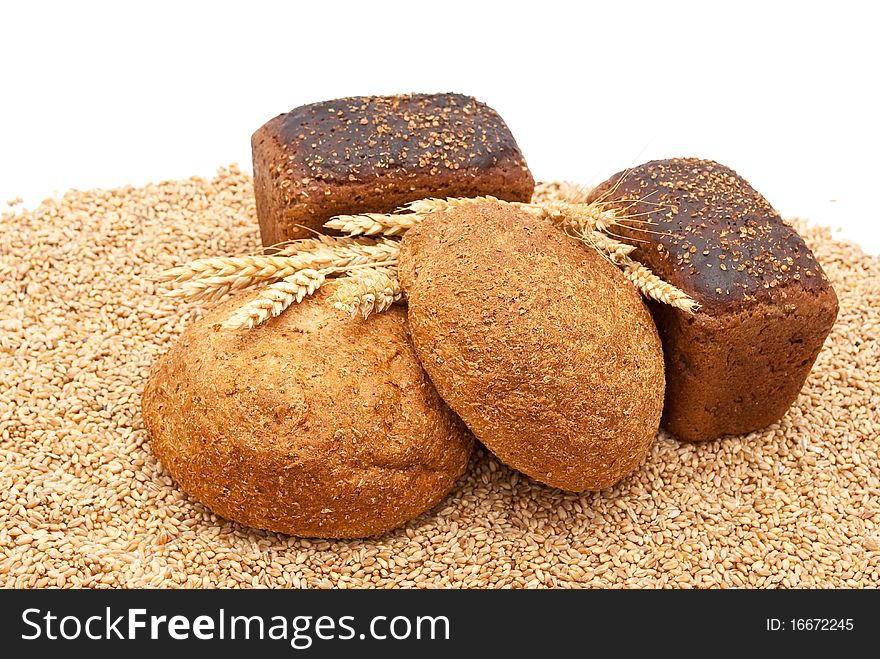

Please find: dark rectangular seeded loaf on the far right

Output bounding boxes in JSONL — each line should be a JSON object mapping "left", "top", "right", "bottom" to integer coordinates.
{"left": 589, "top": 158, "right": 837, "bottom": 441}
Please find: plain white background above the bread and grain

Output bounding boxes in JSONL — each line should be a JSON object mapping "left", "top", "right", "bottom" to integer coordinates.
{"left": 0, "top": 0, "right": 880, "bottom": 253}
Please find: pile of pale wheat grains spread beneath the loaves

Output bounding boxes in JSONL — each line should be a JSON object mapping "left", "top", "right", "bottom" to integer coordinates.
{"left": 0, "top": 168, "right": 880, "bottom": 588}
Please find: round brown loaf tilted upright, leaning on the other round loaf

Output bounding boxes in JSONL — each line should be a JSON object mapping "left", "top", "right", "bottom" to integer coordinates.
{"left": 400, "top": 204, "right": 663, "bottom": 491}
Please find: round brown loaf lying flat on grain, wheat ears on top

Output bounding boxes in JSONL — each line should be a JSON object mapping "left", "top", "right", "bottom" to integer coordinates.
{"left": 143, "top": 283, "right": 473, "bottom": 538}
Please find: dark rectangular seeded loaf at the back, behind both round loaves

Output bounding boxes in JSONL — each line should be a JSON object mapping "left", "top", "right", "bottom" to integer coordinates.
{"left": 251, "top": 94, "right": 535, "bottom": 246}
